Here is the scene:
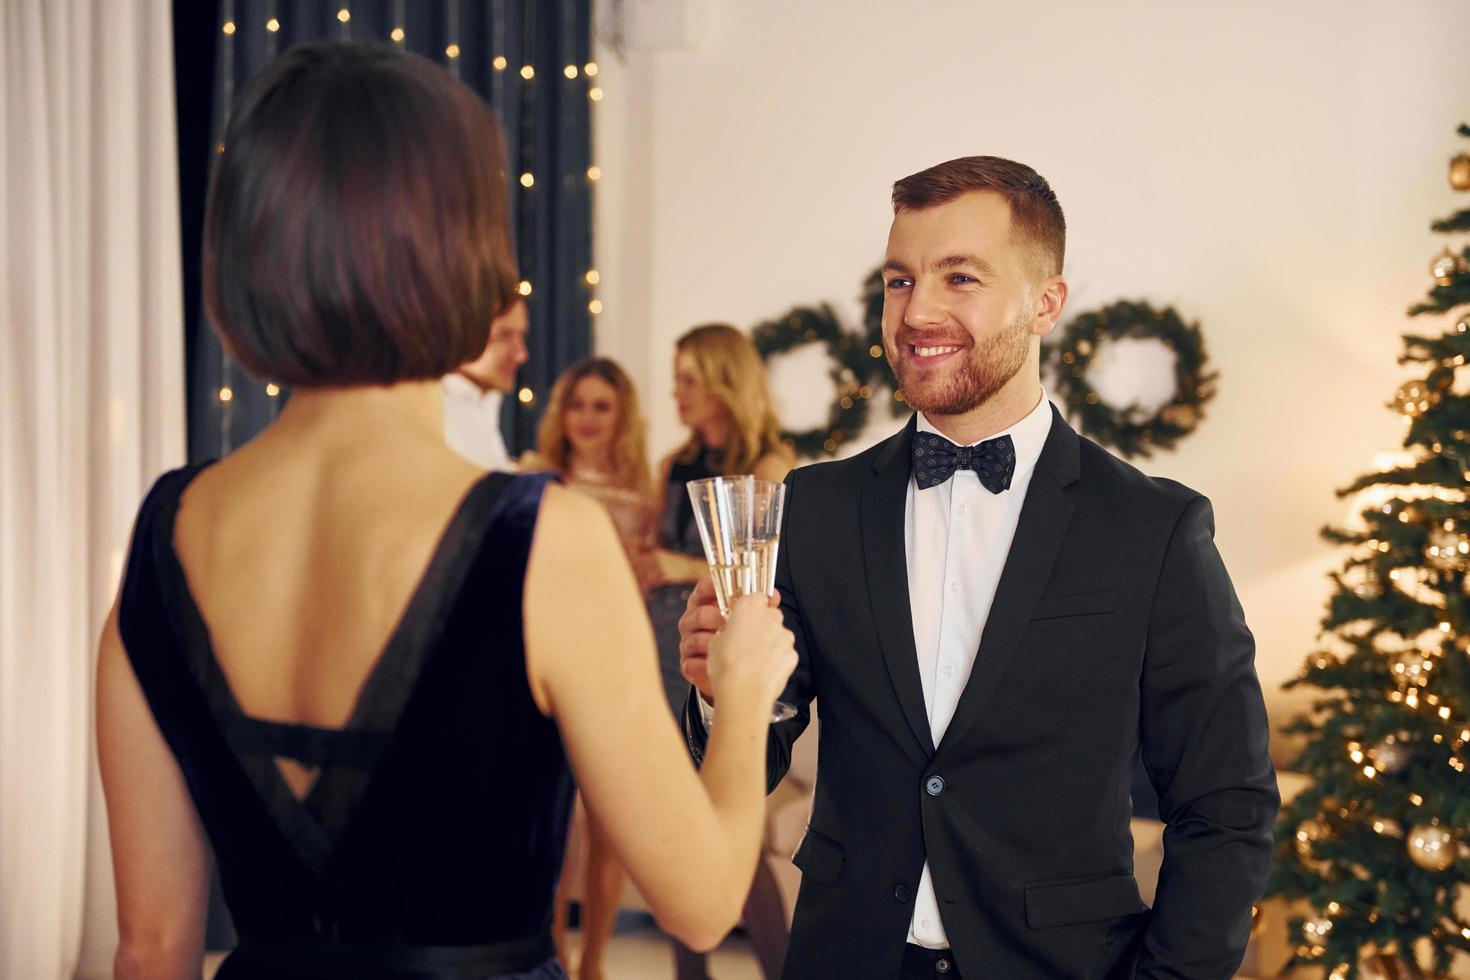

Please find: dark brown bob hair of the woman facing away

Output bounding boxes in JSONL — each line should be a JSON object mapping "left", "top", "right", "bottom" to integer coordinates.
{"left": 203, "top": 41, "right": 517, "bottom": 388}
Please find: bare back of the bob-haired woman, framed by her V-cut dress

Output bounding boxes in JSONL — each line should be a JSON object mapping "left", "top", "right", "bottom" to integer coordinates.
{"left": 173, "top": 433, "right": 484, "bottom": 795}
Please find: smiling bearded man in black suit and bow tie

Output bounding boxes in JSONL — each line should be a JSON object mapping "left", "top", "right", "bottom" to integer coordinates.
{"left": 681, "top": 157, "right": 1279, "bottom": 980}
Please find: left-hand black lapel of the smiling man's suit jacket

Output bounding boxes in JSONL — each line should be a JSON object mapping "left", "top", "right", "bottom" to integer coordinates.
{"left": 863, "top": 416, "right": 933, "bottom": 763}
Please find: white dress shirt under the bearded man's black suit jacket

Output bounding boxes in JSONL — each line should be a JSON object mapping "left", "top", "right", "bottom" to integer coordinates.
{"left": 904, "top": 392, "right": 1051, "bottom": 949}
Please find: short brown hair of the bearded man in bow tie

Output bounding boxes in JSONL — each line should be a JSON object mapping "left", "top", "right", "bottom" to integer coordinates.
{"left": 894, "top": 157, "right": 1067, "bottom": 276}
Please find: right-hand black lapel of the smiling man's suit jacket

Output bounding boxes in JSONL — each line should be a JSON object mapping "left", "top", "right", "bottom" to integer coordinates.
{"left": 939, "top": 407, "right": 1080, "bottom": 751}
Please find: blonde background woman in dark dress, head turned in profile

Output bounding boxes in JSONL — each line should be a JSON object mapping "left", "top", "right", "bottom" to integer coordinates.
{"left": 639, "top": 323, "right": 795, "bottom": 980}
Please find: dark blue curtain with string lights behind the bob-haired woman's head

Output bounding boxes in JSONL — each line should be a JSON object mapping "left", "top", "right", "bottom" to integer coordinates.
{"left": 173, "top": 0, "right": 601, "bottom": 460}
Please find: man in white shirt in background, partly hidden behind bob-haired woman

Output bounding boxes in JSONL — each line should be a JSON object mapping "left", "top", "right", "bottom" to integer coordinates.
{"left": 444, "top": 297, "right": 529, "bottom": 470}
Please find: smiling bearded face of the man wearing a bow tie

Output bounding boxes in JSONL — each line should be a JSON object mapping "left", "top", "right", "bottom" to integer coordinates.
{"left": 883, "top": 191, "right": 1060, "bottom": 416}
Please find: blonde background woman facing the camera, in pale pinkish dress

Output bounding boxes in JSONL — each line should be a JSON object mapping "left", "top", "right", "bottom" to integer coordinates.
{"left": 520, "top": 357, "right": 657, "bottom": 980}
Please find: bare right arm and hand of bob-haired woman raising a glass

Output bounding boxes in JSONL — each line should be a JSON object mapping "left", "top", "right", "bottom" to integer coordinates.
{"left": 525, "top": 486, "right": 795, "bottom": 949}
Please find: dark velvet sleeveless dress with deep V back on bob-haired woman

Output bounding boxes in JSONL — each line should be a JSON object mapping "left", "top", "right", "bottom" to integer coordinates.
{"left": 119, "top": 467, "right": 573, "bottom": 980}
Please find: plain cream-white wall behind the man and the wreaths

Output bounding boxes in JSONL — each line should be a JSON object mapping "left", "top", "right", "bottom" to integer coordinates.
{"left": 597, "top": 0, "right": 1470, "bottom": 705}
